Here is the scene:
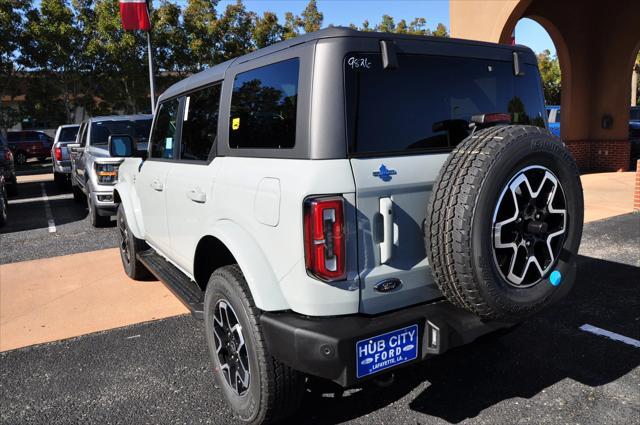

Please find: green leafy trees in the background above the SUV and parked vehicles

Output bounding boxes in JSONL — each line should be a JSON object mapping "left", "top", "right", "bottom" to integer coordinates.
{"left": 8, "top": 0, "right": 448, "bottom": 131}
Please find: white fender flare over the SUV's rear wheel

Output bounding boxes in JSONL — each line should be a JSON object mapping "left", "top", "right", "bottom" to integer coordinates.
{"left": 209, "top": 219, "right": 289, "bottom": 311}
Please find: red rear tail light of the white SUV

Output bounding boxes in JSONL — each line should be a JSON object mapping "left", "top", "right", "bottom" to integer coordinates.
{"left": 304, "top": 196, "right": 346, "bottom": 282}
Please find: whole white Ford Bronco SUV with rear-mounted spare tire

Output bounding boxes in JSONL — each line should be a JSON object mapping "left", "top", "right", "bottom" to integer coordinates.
{"left": 110, "top": 28, "right": 583, "bottom": 423}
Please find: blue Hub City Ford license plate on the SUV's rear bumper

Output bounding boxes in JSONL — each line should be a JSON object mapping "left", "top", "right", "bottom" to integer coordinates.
{"left": 356, "top": 325, "right": 418, "bottom": 378}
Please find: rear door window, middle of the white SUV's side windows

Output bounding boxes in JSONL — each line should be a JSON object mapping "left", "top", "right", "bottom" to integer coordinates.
{"left": 180, "top": 84, "right": 221, "bottom": 161}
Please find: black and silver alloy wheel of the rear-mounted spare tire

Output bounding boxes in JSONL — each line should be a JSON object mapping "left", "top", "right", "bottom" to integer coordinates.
{"left": 492, "top": 166, "right": 569, "bottom": 288}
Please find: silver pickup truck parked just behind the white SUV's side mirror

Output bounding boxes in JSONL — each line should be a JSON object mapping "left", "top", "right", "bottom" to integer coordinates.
{"left": 67, "top": 115, "right": 153, "bottom": 227}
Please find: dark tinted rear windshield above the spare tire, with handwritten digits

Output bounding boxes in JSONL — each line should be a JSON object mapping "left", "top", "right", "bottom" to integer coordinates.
{"left": 345, "top": 54, "right": 545, "bottom": 154}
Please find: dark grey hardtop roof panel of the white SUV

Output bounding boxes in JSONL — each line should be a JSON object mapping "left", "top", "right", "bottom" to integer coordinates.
{"left": 158, "top": 27, "right": 533, "bottom": 101}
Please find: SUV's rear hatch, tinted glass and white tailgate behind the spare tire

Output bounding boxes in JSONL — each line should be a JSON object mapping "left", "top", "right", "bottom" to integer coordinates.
{"left": 344, "top": 51, "right": 546, "bottom": 314}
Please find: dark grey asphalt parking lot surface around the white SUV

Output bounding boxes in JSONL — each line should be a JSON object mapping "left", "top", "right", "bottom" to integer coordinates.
{"left": 0, "top": 163, "right": 640, "bottom": 424}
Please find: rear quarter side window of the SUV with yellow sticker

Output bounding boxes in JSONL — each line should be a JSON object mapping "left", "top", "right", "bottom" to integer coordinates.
{"left": 229, "top": 58, "right": 300, "bottom": 149}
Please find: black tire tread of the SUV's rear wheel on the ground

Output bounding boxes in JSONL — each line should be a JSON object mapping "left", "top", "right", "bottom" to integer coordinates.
{"left": 208, "top": 264, "right": 304, "bottom": 424}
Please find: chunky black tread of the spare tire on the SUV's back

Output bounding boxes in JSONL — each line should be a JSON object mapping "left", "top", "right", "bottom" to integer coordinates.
{"left": 425, "top": 125, "right": 578, "bottom": 319}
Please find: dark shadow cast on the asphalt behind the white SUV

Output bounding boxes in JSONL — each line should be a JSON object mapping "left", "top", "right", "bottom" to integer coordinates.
{"left": 290, "top": 256, "right": 640, "bottom": 424}
